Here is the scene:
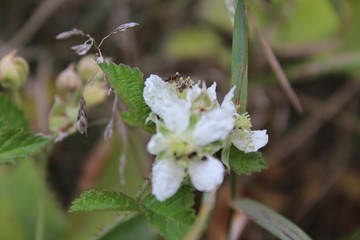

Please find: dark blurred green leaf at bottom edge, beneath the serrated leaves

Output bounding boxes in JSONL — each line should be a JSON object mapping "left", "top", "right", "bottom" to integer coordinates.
{"left": 95, "top": 213, "right": 158, "bottom": 240}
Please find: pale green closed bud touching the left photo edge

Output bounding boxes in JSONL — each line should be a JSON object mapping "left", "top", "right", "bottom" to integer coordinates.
{"left": 0, "top": 50, "right": 29, "bottom": 89}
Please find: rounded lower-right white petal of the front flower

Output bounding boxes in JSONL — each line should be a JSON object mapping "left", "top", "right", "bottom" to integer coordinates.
{"left": 188, "top": 156, "right": 225, "bottom": 192}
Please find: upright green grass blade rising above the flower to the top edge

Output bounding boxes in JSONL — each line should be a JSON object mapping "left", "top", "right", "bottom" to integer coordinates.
{"left": 231, "top": 0, "right": 248, "bottom": 114}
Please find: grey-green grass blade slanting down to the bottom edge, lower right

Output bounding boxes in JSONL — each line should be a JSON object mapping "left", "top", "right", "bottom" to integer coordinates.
{"left": 231, "top": 199, "right": 311, "bottom": 240}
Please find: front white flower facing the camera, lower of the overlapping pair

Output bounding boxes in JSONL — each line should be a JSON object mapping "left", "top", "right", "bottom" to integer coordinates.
{"left": 147, "top": 100, "right": 234, "bottom": 201}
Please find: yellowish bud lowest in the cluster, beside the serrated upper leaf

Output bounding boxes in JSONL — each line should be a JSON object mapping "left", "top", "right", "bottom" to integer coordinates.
{"left": 84, "top": 81, "right": 108, "bottom": 106}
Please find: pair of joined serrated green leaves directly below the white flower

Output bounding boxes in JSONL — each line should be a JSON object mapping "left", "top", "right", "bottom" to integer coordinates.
{"left": 70, "top": 186, "right": 195, "bottom": 239}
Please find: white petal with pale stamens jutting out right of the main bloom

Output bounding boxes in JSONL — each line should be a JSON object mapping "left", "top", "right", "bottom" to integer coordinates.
{"left": 230, "top": 129, "right": 269, "bottom": 153}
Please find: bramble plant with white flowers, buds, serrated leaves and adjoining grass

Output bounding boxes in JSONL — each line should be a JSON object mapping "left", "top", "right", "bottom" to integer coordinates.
{"left": 0, "top": 0, "right": 316, "bottom": 239}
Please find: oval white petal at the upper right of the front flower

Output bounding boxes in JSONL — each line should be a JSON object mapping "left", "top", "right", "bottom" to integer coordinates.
{"left": 193, "top": 108, "right": 234, "bottom": 146}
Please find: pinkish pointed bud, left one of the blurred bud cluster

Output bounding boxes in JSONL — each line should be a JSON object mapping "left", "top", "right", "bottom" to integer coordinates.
{"left": 56, "top": 64, "right": 82, "bottom": 90}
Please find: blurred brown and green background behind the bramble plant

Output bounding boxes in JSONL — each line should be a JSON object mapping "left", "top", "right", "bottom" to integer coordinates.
{"left": 0, "top": 0, "right": 360, "bottom": 239}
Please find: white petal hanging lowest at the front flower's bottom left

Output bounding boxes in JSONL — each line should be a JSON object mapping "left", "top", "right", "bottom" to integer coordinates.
{"left": 151, "top": 159, "right": 185, "bottom": 202}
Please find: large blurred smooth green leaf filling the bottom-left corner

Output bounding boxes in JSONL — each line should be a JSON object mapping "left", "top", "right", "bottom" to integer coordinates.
{"left": 0, "top": 159, "right": 67, "bottom": 240}
